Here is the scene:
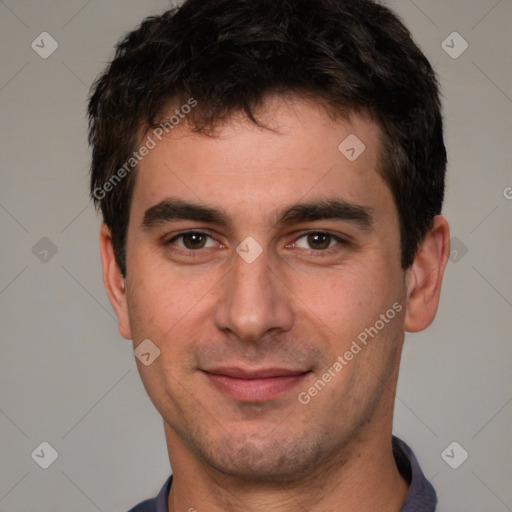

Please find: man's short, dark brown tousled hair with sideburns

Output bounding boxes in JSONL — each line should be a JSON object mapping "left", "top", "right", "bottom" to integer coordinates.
{"left": 88, "top": 0, "right": 446, "bottom": 275}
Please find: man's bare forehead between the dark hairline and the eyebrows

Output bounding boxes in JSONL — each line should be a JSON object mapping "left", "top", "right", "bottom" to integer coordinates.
{"left": 132, "top": 98, "right": 391, "bottom": 223}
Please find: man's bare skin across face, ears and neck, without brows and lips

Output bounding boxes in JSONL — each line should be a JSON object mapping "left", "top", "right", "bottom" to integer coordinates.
{"left": 100, "top": 97, "right": 449, "bottom": 512}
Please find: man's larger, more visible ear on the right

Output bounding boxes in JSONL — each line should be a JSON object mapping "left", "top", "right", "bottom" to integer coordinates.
{"left": 404, "top": 215, "right": 450, "bottom": 332}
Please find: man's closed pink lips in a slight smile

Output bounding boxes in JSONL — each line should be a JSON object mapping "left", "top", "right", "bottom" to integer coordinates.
{"left": 203, "top": 367, "right": 310, "bottom": 402}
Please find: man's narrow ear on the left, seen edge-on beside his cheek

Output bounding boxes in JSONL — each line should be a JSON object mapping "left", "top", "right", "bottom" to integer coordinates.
{"left": 100, "top": 224, "right": 132, "bottom": 340}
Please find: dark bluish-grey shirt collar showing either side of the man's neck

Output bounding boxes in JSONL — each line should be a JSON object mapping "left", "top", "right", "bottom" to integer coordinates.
{"left": 129, "top": 436, "right": 437, "bottom": 512}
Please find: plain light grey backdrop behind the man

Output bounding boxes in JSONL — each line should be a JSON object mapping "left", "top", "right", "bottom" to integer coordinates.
{"left": 0, "top": 0, "right": 512, "bottom": 512}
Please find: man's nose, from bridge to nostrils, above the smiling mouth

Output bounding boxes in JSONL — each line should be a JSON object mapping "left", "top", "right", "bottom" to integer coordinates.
{"left": 215, "top": 245, "right": 293, "bottom": 343}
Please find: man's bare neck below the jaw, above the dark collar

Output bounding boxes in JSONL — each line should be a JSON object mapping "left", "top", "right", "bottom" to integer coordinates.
{"left": 165, "top": 425, "right": 408, "bottom": 512}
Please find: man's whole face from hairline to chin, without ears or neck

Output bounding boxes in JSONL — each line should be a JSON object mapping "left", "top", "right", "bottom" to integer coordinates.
{"left": 121, "top": 99, "right": 405, "bottom": 479}
